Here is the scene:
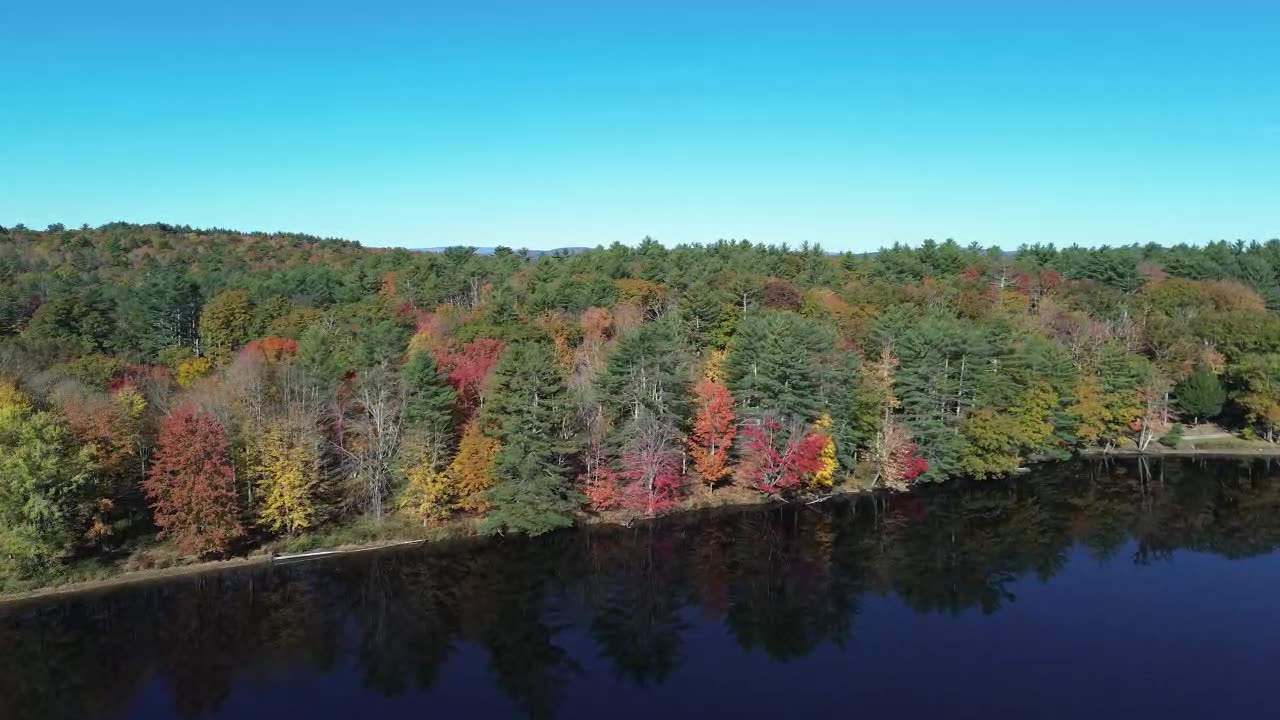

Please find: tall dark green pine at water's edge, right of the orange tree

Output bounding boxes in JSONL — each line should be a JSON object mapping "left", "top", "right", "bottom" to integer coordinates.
{"left": 481, "top": 342, "right": 584, "bottom": 536}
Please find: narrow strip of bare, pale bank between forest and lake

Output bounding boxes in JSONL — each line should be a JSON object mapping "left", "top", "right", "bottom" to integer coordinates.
{"left": 0, "top": 443, "right": 1280, "bottom": 604}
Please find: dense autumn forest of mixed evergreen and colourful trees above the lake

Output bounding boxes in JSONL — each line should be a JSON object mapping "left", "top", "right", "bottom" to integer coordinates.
{"left": 0, "top": 223, "right": 1280, "bottom": 579}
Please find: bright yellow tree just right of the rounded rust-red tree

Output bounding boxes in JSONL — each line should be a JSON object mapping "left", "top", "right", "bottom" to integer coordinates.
{"left": 252, "top": 423, "right": 320, "bottom": 534}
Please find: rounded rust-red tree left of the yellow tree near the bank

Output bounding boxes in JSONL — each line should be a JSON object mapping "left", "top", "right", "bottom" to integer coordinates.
{"left": 142, "top": 407, "right": 244, "bottom": 555}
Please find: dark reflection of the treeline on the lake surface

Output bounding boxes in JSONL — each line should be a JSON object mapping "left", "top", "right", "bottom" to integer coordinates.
{"left": 0, "top": 460, "right": 1280, "bottom": 720}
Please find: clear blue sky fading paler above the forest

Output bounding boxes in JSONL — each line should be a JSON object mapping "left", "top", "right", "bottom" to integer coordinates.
{"left": 0, "top": 0, "right": 1280, "bottom": 250}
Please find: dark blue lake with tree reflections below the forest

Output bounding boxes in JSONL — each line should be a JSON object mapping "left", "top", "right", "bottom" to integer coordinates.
{"left": 0, "top": 461, "right": 1280, "bottom": 720}
